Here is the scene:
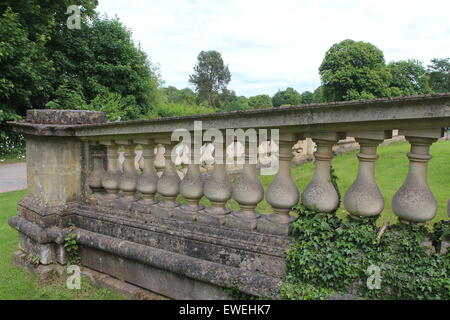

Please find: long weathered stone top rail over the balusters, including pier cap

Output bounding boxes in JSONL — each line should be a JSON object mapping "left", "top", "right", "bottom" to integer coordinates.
{"left": 7, "top": 92, "right": 450, "bottom": 138}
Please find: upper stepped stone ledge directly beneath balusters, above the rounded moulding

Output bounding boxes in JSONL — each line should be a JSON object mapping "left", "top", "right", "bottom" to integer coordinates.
{"left": 74, "top": 206, "right": 288, "bottom": 278}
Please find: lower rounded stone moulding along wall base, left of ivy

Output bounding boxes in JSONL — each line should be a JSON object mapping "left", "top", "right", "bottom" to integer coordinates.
{"left": 77, "top": 229, "right": 282, "bottom": 299}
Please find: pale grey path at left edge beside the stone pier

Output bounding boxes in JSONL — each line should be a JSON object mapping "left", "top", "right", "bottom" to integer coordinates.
{"left": 0, "top": 162, "right": 27, "bottom": 192}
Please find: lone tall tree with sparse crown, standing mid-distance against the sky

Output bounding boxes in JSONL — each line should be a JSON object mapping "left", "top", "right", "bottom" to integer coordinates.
{"left": 189, "top": 50, "right": 231, "bottom": 107}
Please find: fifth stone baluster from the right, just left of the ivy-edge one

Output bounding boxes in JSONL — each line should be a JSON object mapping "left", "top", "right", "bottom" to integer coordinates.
{"left": 233, "top": 139, "right": 264, "bottom": 224}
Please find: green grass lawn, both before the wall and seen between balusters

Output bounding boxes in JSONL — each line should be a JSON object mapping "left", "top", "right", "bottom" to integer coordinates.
{"left": 0, "top": 141, "right": 450, "bottom": 299}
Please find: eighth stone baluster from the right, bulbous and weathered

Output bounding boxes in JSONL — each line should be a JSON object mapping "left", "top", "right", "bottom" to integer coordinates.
{"left": 157, "top": 139, "right": 180, "bottom": 208}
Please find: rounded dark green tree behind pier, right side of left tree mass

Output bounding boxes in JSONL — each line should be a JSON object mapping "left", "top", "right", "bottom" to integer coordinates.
{"left": 47, "top": 17, "right": 161, "bottom": 120}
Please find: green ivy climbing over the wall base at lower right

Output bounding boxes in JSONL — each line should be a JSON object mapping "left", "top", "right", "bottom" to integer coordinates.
{"left": 280, "top": 168, "right": 450, "bottom": 300}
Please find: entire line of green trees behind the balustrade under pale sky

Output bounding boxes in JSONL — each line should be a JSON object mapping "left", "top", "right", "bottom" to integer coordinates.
{"left": 0, "top": 0, "right": 450, "bottom": 137}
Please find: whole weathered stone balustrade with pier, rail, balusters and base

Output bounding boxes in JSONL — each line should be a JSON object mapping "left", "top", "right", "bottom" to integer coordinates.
{"left": 7, "top": 94, "right": 450, "bottom": 298}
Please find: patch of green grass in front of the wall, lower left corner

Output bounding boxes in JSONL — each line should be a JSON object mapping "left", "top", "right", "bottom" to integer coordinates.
{"left": 0, "top": 190, "right": 124, "bottom": 300}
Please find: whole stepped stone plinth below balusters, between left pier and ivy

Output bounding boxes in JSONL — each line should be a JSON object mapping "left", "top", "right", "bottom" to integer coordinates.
{"left": 73, "top": 205, "right": 291, "bottom": 299}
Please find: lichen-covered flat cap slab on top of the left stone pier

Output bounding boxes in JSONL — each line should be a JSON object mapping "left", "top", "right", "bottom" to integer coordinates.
{"left": 26, "top": 109, "right": 106, "bottom": 125}
